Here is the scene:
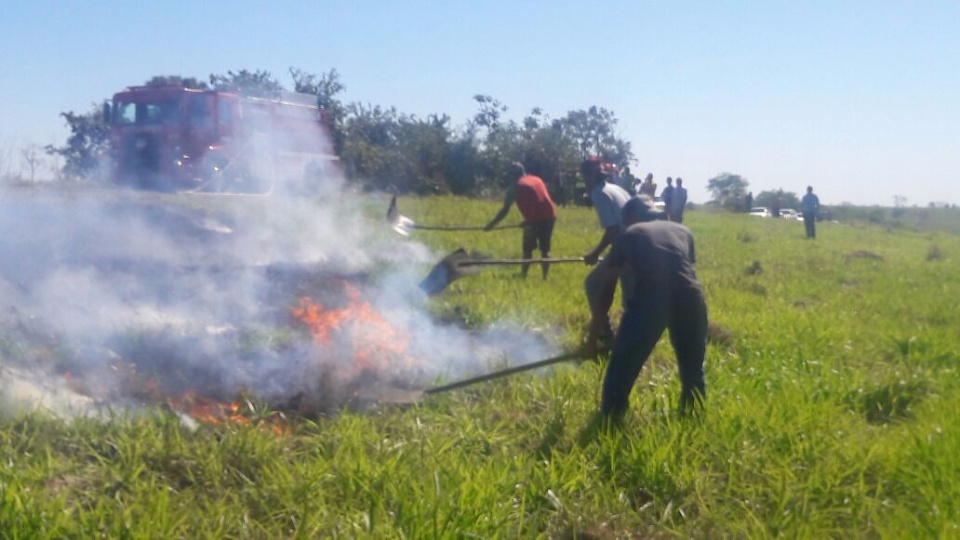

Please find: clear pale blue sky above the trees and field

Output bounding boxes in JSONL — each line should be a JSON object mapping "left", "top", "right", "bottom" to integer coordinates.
{"left": 0, "top": 0, "right": 960, "bottom": 206}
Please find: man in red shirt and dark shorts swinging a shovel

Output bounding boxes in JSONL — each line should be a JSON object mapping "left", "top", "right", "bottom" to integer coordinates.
{"left": 483, "top": 162, "right": 557, "bottom": 279}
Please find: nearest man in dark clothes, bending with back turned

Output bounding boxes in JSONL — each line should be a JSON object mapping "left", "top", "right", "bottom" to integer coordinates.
{"left": 584, "top": 197, "right": 707, "bottom": 419}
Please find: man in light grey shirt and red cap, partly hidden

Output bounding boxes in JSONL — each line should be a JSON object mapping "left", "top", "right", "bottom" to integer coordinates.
{"left": 580, "top": 158, "right": 630, "bottom": 344}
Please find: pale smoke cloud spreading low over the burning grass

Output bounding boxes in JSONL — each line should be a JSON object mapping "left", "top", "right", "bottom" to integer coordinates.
{"left": 0, "top": 160, "right": 550, "bottom": 422}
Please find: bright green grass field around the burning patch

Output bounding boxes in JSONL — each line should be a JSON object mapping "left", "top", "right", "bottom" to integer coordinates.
{"left": 0, "top": 198, "right": 960, "bottom": 538}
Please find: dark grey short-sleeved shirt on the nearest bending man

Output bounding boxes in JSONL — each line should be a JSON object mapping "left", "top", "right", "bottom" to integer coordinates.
{"left": 607, "top": 221, "right": 701, "bottom": 306}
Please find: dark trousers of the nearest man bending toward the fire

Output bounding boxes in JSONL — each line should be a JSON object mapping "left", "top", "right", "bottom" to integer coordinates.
{"left": 600, "top": 291, "right": 707, "bottom": 416}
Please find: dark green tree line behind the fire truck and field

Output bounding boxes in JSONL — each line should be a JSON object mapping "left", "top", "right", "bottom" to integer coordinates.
{"left": 45, "top": 68, "right": 635, "bottom": 202}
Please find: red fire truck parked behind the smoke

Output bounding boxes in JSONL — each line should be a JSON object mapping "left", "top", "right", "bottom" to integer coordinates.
{"left": 104, "top": 85, "right": 339, "bottom": 193}
